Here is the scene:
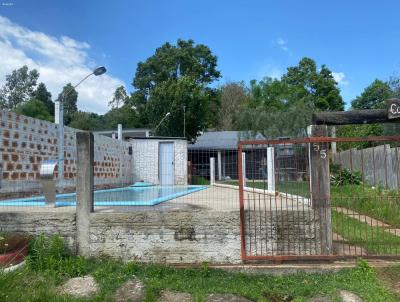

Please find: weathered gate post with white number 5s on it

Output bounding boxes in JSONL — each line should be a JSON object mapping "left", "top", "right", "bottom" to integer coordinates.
{"left": 309, "top": 125, "right": 333, "bottom": 255}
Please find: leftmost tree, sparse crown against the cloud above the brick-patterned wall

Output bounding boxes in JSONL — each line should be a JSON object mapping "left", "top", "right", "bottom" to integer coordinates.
{"left": 0, "top": 65, "right": 39, "bottom": 110}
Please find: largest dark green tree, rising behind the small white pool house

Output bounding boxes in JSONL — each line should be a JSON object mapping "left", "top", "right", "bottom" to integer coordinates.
{"left": 130, "top": 40, "right": 220, "bottom": 139}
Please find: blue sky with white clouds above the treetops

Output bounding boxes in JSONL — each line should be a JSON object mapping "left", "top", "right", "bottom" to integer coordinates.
{"left": 0, "top": 0, "right": 400, "bottom": 113}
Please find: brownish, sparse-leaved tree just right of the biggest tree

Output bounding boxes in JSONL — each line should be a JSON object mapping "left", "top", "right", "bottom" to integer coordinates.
{"left": 216, "top": 82, "right": 248, "bottom": 130}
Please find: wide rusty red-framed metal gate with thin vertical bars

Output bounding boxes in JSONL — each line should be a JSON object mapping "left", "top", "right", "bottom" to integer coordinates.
{"left": 238, "top": 136, "right": 400, "bottom": 261}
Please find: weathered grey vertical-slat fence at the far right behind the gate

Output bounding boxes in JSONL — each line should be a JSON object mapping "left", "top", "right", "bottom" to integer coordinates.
{"left": 332, "top": 145, "right": 400, "bottom": 190}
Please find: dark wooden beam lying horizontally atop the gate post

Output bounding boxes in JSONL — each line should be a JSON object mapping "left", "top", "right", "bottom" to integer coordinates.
{"left": 312, "top": 109, "right": 395, "bottom": 125}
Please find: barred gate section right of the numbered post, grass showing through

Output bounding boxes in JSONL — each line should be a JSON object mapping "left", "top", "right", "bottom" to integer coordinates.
{"left": 331, "top": 137, "right": 400, "bottom": 258}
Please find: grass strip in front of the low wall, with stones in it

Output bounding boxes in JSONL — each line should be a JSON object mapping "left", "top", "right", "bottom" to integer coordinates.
{"left": 0, "top": 239, "right": 400, "bottom": 302}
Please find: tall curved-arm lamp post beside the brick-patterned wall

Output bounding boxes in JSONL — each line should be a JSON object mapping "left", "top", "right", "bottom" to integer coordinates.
{"left": 54, "top": 66, "right": 107, "bottom": 182}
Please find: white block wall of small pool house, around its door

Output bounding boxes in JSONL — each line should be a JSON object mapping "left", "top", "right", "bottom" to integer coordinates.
{"left": 130, "top": 139, "right": 187, "bottom": 185}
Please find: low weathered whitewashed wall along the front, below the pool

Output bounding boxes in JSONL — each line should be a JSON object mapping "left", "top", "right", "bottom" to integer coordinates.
{"left": 0, "top": 208, "right": 320, "bottom": 263}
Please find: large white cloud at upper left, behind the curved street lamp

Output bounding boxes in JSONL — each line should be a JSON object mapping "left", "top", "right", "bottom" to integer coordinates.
{"left": 0, "top": 16, "right": 124, "bottom": 113}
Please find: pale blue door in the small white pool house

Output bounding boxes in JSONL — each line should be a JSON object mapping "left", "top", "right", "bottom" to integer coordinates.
{"left": 158, "top": 143, "right": 174, "bottom": 186}
